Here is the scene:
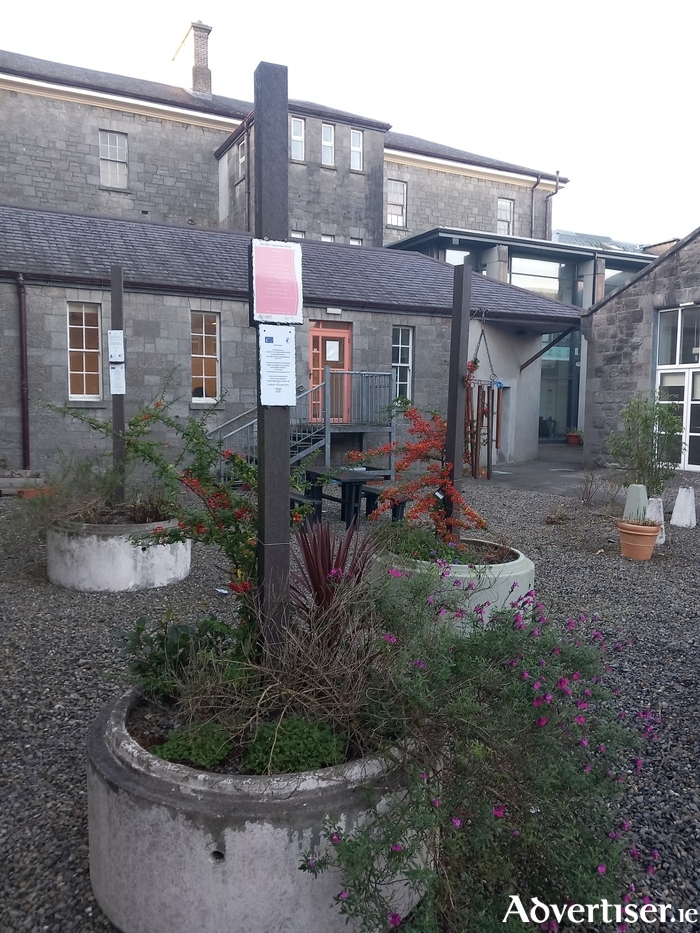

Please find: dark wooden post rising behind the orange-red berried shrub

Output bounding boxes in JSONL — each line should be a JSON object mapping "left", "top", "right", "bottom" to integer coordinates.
{"left": 445, "top": 260, "right": 472, "bottom": 518}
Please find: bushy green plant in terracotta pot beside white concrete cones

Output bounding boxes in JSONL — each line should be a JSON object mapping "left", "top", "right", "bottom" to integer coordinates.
{"left": 606, "top": 392, "right": 683, "bottom": 560}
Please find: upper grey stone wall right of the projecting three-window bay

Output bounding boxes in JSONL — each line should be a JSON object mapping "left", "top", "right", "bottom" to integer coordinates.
{"left": 383, "top": 161, "right": 551, "bottom": 243}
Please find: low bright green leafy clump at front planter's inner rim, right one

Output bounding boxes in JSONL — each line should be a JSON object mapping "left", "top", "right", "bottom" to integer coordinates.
{"left": 245, "top": 716, "right": 347, "bottom": 774}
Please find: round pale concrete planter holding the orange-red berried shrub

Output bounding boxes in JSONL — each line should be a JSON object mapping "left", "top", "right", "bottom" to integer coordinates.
{"left": 392, "top": 538, "right": 535, "bottom": 629}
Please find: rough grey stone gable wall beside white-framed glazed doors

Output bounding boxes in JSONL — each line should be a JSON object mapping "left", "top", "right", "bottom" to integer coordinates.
{"left": 581, "top": 237, "right": 700, "bottom": 467}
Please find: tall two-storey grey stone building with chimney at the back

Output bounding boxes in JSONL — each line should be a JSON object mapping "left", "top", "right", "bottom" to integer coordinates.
{"left": 0, "top": 23, "right": 567, "bottom": 246}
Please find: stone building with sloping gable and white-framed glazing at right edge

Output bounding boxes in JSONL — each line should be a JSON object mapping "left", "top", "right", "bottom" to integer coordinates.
{"left": 581, "top": 228, "right": 700, "bottom": 470}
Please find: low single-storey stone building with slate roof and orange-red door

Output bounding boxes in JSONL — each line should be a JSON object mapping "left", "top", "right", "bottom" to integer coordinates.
{"left": 0, "top": 201, "right": 578, "bottom": 469}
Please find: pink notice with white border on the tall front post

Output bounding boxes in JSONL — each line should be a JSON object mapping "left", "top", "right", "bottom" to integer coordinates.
{"left": 253, "top": 240, "right": 302, "bottom": 324}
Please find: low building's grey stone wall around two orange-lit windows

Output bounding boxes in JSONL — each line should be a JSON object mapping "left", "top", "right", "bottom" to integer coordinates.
{"left": 0, "top": 284, "right": 257, "bottom": 469}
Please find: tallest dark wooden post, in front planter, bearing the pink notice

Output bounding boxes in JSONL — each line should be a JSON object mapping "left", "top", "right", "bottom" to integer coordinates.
{"left": 253, "top": 62, "right": 290, "bottom": 643}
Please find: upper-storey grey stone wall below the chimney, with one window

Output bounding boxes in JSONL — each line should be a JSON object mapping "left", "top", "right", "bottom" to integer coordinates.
{"left": 0, "top": 90, "right": 227, "bottom": 226}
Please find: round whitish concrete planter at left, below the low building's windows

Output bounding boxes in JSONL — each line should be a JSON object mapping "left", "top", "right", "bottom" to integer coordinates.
{"left": 46, "top": 522, "right": 192, "bottom": 593}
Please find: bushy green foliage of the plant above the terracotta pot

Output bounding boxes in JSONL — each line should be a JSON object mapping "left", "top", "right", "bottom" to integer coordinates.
{"left": 606, "top": 392, "right": 684, "bottom": 496}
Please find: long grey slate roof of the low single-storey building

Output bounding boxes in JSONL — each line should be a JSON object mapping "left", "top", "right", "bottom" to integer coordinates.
{"left": 0, "top": 207, "right": 579, "bottom": 327}
